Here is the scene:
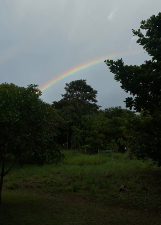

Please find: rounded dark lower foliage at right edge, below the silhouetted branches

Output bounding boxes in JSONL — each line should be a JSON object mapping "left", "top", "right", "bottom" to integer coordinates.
{"left": 123, "top": 112, "right": 161, "bottom": 166}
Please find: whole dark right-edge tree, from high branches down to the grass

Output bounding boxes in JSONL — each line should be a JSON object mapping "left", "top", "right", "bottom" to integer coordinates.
{"left": 105, "top": 13, "right": 161, "bottom": 166}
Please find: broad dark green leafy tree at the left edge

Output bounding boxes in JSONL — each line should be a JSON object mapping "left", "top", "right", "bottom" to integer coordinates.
{"left": 0, "top": 83, "right": 62, "bottom": 203}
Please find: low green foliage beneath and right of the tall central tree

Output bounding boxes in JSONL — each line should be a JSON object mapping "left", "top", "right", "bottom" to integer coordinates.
{"left": 52, "top": 103, "right": 135, "bottom": 154}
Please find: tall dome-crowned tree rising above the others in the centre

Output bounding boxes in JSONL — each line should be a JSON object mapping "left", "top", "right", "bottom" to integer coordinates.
{"left": 52, "top": 80, "right": 99, "bottom": 148}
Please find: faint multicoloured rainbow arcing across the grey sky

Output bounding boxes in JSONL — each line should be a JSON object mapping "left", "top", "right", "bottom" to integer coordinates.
{"left": 39, "top": 51, "right": 143, "bottom": 92}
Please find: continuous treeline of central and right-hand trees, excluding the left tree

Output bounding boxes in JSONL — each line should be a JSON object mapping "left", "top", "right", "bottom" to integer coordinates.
{"left": 52, "top": 13, "right": 161, "bottom": 166}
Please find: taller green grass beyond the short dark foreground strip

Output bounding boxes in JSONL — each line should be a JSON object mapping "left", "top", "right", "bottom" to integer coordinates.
{"left": 3, "top": 151, "right": 161, "bottom": 209}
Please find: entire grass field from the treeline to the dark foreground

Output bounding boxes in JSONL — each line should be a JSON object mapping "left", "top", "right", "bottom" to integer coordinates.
{"left": 0, "top": 151, "right": 161, "bottom": 225}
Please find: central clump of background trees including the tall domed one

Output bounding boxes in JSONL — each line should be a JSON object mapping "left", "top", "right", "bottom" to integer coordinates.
{"left": 52, "top": 80, "right": 136, "bottom": 153}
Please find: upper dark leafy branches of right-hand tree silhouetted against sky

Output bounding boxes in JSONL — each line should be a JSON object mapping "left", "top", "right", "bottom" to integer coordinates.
{"left": 105, "top": 13, "right": 161, "bottom": 114}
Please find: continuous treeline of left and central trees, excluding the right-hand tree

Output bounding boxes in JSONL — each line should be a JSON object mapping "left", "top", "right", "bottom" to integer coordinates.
{"left": 0, "top": 80, "right": 135, "bottom": 203}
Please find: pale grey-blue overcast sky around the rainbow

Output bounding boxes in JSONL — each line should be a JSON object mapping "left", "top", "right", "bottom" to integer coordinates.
{"left": 0, "top": 0, "right": 161, "bottom": 108}
